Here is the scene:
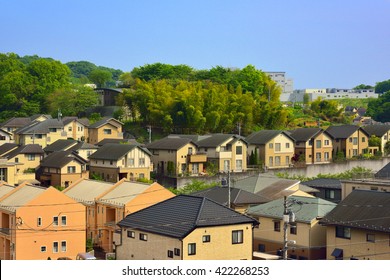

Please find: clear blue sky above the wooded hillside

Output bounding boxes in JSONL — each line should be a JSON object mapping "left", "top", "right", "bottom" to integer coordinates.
{"left": 0, "top": 0, "right": 390, "bottom": 89}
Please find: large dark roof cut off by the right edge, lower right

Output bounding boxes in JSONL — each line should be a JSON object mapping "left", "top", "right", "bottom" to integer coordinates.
{"left": 320, "top": 190, "right": 390, "bottom": 233}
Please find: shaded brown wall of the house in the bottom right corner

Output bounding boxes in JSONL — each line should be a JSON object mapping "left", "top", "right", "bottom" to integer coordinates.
{"left": 326, "top": 226, "right": 390, "bottom": 260}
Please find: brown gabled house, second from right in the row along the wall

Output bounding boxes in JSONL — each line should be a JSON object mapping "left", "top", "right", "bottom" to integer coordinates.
{"left": 325, "top": 125, "right": 369, "bottom": 158}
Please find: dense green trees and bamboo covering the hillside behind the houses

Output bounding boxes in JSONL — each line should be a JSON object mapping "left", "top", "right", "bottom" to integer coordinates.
{"left": 0, "top": 53, "right": 390, "bottom": 135}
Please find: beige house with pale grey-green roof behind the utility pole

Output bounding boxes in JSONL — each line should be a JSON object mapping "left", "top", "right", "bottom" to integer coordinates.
{"left": 247, "top": 195, "right": 336, "bottom": 260}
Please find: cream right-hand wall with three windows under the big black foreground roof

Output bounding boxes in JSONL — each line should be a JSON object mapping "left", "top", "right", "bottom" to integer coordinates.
{"left": 183, "top": 224, "right": 253, "bottom": 260}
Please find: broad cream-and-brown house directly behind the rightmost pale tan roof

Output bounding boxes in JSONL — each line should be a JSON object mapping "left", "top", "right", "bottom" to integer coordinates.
{"left": 89, "top": 144, "right": 153, "bottom": 182}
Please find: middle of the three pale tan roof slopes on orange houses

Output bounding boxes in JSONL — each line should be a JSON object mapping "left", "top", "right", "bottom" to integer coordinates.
{"left": 62, "top": 179, "right": 114, "bottom": 205}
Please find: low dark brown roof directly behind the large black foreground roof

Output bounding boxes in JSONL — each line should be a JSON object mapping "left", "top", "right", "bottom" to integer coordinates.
{"left": 191, "top": 186, "right": 269, "bottom": 206}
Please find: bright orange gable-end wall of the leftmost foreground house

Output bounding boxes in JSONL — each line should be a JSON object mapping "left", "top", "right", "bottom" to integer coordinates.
{"left": 15, "top": 188, "right": 85, "bottom": 260}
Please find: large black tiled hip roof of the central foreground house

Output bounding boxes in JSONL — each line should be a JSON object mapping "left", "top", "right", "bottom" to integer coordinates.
{"left": 118, "top": 195, "right": 259, "bottom": 238}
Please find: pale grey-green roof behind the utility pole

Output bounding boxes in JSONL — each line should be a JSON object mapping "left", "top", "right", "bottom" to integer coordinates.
{"left": 247, "top": 196, "right": 336, "bottom": 223}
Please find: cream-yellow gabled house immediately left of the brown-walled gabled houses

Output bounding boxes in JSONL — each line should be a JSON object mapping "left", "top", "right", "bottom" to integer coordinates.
{"left": 246, "top": 130, "right": 294, "bottom": 169}
